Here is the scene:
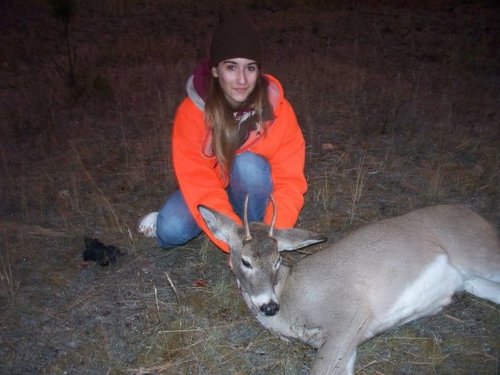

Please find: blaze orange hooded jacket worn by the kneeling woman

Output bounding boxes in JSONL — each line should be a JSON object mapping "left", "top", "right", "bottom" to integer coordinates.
{"left": 172, "top": 75, "right": 307, "bottom": 252}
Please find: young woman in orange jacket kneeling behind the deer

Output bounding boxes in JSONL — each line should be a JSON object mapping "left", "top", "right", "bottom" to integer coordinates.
{"left": 138, "top": 8, "right": 307, "bottom": 252}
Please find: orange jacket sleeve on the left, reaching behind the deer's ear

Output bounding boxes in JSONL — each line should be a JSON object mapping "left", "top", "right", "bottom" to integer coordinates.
{"left": 172, "top": 98, "right": 241, "bottom": 252}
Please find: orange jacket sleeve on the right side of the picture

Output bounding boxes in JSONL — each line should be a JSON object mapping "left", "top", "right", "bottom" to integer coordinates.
{"left": 264, "top": 99, "right": 307, "bottom": 228}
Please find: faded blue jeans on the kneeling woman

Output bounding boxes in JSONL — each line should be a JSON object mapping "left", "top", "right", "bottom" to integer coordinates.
{"left": 156, "top": 152, "right": 273, "bottom": 249}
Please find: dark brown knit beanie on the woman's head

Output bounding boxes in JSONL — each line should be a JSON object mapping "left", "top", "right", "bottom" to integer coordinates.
{"left": 210, "top": 6, "right": 261, "bottom": 66}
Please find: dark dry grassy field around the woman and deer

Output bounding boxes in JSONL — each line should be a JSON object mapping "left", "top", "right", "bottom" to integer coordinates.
{"left": 0, "top": 0, "right": 500, "bottom": 375}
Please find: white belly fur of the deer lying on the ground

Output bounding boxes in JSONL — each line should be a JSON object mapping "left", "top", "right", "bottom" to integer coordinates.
{"left": 366, "top": 255, "right": 464, "bottom": 338}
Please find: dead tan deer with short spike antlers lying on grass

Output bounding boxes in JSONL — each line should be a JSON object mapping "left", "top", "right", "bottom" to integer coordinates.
{"left": 198, "top": 197, "right": 500, "bottom": 375}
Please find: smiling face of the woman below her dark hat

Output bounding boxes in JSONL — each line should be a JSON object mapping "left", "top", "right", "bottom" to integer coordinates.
{"left": 212, "top": 58, "right": 259, "bottom": 108}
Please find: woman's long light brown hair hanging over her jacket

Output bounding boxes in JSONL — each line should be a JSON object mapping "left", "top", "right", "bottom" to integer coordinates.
{"left": 205, "top": 74, "right": 268, "bottom": 178}
